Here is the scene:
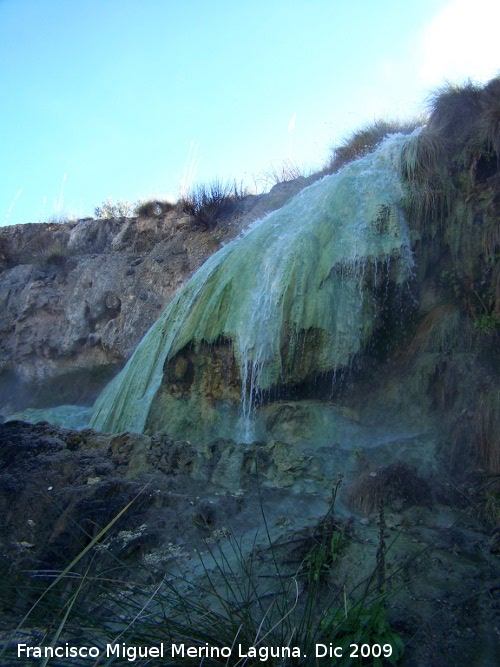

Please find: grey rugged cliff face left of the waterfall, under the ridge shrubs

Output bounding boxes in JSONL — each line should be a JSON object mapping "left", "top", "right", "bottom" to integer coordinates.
{"left": 0, "top": 185, "right": 307, "bottom": 414}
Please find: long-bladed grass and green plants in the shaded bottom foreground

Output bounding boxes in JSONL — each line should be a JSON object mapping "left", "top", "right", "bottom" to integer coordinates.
{"left": 0, "top": 476, "right": 404, "bottom": 667}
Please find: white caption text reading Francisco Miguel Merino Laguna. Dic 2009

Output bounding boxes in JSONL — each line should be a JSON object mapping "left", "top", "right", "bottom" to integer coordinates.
{"left": 17, "top": 642, "right": 386, "bottom": 662}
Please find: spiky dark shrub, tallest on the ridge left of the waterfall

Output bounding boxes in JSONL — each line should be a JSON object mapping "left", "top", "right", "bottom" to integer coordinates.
{"left": 180, "top": 180, "right": 247, "bottom": 230}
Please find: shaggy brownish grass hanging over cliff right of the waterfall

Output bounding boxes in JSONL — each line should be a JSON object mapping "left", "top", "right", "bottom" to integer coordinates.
{"left": 399, "top": 77, "right": 500, "bottom": 326}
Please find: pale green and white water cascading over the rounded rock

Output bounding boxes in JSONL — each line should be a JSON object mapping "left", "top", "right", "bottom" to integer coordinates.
{"left": 90, "top": 136, "right": 412, "bottom": 436}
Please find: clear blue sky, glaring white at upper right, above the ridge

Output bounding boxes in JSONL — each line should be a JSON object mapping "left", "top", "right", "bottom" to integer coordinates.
{"left": 0, "top": 0, "right": 500, "bottom": 226}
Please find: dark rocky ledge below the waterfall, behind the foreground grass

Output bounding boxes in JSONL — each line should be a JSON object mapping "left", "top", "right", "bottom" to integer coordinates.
{"left": 0, "top": 421, "right": 332, "bottom": 569}
